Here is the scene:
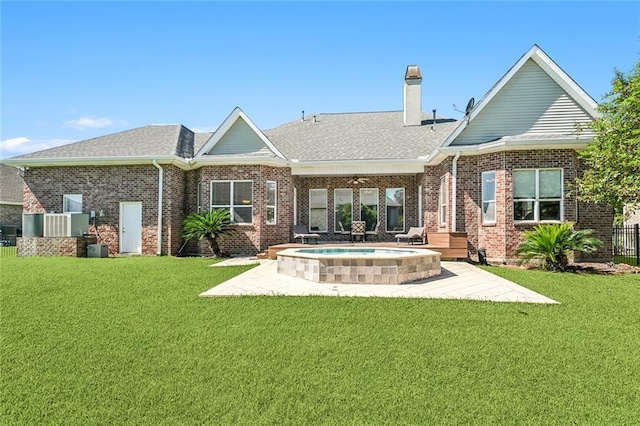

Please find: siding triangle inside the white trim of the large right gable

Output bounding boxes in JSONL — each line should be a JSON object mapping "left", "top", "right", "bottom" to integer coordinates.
{"left": 451, "top": 59, "right": 592, "bottom": 146}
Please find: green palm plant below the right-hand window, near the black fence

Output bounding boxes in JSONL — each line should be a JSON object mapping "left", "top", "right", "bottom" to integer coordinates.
{"left": 516, "top": 222, "right": 602, "bottom": 271}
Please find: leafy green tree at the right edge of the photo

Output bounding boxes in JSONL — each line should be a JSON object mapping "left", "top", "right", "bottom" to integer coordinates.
{"left": 578, "top": 60, "right": 640, "bottom": 222}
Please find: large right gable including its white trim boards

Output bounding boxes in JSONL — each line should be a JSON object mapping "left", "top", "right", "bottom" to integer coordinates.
{"left": 442, "top": 44, "right": 597, "bottom": 147}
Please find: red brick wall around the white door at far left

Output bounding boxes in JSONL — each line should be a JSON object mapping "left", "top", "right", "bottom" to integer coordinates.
{"left": 24, "top": 164, "right": 186, "bottom": 254}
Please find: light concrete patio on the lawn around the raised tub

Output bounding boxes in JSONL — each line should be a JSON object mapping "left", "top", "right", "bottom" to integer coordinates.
{"left": 200, "top": 258, "right": 559, "bottom": 304}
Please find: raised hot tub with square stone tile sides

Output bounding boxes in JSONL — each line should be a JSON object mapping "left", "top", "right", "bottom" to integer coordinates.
{"left": 278, "top": 247, "right": 440, "bottom": 284}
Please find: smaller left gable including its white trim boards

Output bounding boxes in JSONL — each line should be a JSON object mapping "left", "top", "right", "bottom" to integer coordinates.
{"left": 195, "top": 107, "right": 285, "bottom": 160}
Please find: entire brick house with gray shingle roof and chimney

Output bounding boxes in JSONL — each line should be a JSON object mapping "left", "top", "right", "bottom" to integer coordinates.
{"left": 5, "top": 45, "right": 613, "bottom": 261}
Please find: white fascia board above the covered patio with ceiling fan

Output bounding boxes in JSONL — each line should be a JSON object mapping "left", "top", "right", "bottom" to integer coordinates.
{"left": 290, "top": 159, "right": 425, "bottom": 176}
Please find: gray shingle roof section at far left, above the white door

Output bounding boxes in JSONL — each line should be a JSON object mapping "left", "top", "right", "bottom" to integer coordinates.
{"left": 9, "top": 124, "right": 194, "bottom": 159}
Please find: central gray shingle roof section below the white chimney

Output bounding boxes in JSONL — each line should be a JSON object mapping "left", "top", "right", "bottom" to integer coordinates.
{"left": 264, "top": 111, "right": 458, "bottom": 161}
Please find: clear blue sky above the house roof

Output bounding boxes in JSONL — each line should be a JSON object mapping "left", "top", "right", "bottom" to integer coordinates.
{"left": 0, "top": 1, "right": 640, "bottom": 158}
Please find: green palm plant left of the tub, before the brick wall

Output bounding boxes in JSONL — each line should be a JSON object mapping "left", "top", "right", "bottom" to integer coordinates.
{"left": 182, "top": 209, "right": 233, "bottom": 257}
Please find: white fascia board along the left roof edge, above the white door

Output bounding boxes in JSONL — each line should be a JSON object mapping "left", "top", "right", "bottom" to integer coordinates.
{"left": 2, "top": 155, "right": 189, "bottom": 170}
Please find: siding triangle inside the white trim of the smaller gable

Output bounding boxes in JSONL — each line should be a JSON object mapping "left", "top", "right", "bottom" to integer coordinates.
{"left": 206, "top": 117, "right": 274, "bottom": 156}
